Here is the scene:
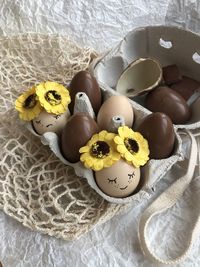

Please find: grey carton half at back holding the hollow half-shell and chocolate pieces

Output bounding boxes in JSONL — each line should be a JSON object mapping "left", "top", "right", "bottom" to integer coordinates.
{"left": 91, "top": 26, "right": 200, "bottom": 130}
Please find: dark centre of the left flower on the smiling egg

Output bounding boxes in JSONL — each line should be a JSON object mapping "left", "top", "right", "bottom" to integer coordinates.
{"left": 91, "top": 141, "right": 110, "bottom": 159}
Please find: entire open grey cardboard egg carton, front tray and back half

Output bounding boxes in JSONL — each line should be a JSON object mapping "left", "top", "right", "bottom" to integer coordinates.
{"left": 28, "top": 26, "right": 200, "bottom": 205}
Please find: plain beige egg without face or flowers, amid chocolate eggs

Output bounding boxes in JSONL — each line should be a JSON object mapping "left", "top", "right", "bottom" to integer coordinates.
{"left": 97, "top": 95, "right": 134, "bottom": 130}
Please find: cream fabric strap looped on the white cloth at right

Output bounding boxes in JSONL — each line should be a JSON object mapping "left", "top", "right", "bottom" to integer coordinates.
{"left": 139, "top": 131, "right": 200, "bottom": 264}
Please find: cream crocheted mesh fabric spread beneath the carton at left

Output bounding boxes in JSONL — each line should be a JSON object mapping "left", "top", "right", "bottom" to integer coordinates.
{"left": 0, "top": 34, "right": 128, "bottom": 240}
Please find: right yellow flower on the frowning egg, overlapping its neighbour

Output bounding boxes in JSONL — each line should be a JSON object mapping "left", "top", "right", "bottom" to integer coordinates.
{"left": 36, "top": 82, "right": 71, "bottom": 115}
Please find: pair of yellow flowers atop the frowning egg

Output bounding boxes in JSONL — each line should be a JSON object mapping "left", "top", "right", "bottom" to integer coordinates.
{"left": 15, "top": 81, "right": 71, "bottom": 121}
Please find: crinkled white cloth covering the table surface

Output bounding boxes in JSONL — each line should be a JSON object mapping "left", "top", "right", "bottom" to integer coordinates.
{"left": 0, "top": 0, "right": 200, "bottom": 267}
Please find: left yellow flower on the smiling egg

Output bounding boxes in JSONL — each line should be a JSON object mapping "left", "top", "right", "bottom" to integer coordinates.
{"left": 79, "top": 131, "right": 120, "bottom": 171}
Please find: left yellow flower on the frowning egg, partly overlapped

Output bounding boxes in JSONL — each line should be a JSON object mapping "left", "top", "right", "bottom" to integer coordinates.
{"left": 15, "top": 86, "right": 42, "bottom": 121}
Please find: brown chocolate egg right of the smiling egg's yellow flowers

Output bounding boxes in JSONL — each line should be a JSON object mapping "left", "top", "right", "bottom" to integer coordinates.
{"left": 137, "top": 112, "right": 175, "bottom": 159}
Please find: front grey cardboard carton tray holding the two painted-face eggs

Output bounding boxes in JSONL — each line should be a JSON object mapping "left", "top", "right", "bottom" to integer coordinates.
{"left": 27, "top": 88, "right": 183, "bottom": 206}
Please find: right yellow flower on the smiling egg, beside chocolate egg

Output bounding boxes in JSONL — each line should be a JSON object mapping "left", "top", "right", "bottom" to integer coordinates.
{"left": 114, "top": 126, "right": 149, "bottom": 168}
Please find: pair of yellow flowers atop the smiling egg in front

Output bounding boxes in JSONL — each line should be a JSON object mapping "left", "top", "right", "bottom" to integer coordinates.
{"left": 79, "top": 126, "right": 149, "bottom": 171}
